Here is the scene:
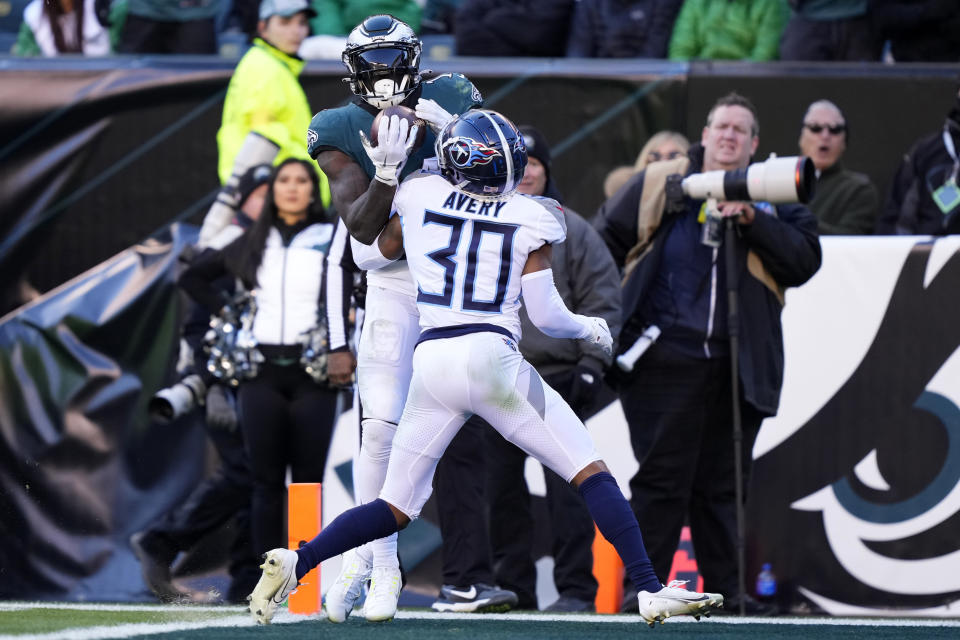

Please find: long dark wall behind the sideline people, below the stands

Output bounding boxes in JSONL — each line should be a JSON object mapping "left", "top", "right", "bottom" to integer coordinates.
{"left": 0, "top": 57, "right": 957, "bottom": 304}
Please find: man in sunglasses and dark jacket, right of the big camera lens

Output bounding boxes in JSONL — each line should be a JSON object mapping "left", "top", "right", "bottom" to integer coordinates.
{"left": 799, "top": 100, "right": 880, "bottom": 235}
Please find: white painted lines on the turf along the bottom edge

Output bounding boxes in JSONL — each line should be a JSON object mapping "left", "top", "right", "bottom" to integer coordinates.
{"left": 0, "top": 602, "right": 960, "bottom": 640}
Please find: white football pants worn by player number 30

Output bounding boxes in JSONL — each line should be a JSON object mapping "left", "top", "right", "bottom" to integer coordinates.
{"left": 380, "top": 332, "right": 600, "bottom": 519}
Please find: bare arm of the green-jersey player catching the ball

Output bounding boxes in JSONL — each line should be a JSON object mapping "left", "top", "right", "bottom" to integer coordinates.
{"left": 317, "top": 150, "right": 397, "bottom": 245}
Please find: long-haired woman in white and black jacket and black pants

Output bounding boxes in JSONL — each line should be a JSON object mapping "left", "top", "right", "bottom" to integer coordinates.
{"left": 180, "top": 158, "right": 348, "bottom": 550}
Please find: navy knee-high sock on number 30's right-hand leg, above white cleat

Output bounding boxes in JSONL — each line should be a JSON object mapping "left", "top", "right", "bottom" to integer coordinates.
{"left": 580, "top": 471, "right": 662, "bottom": 593}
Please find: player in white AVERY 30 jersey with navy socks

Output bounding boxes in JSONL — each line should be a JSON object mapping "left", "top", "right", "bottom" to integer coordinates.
{"left": 250, "top": 110, "right": 723, "bottom": 625}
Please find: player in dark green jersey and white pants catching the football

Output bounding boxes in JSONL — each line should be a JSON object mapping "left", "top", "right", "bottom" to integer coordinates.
{"left": 307, "top": 15, "right": 498, "bottom": 622}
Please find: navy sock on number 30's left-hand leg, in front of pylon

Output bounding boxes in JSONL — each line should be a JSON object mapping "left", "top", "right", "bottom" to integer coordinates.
{"left": 297, "top": 498, "right": 397, "bottom": 580}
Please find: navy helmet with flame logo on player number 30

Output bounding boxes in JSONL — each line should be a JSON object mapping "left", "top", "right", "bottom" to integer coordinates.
{"left": 436, "top": 109, "right": 527, "bottom": 200}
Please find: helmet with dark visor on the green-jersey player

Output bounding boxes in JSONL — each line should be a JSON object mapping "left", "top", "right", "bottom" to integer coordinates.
{"left": 341, "top": 14, "right": 422, "bottom": 109}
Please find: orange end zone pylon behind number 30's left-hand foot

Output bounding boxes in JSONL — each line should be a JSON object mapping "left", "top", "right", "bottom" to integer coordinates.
{"left": 287, "top": 482, "right": 323, "bottom": 614}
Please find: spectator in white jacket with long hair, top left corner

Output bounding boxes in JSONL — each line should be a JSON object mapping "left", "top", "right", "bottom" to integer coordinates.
{"left": 13, "top": 0, "right": 127, "bottom": 58}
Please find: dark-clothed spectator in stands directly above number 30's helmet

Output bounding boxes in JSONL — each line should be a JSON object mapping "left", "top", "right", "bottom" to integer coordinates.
{"left": 454, "top": 0, "right": 574, "bottom": 58}
